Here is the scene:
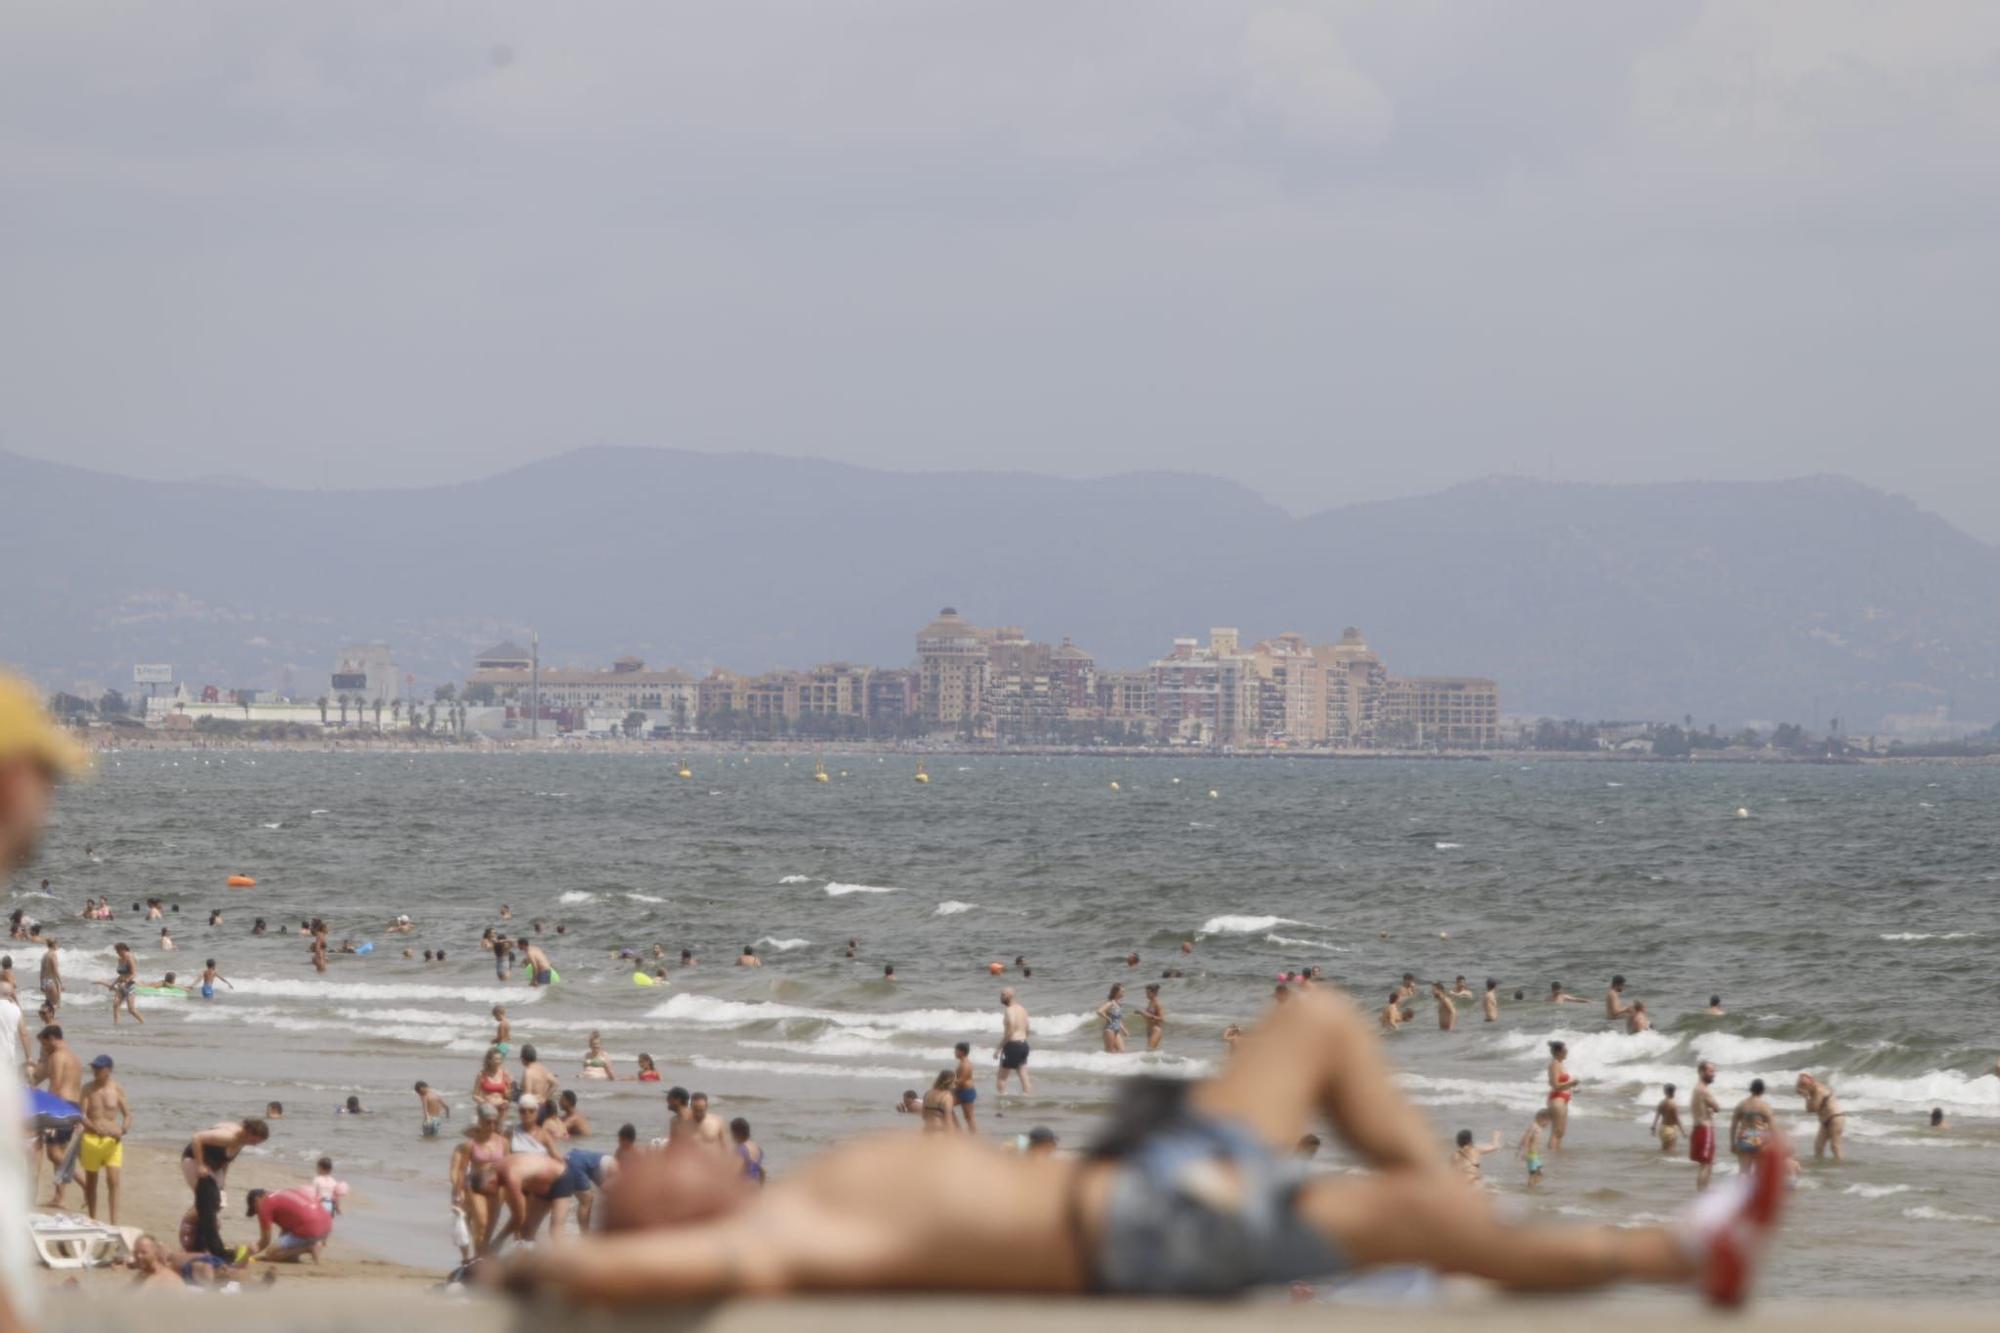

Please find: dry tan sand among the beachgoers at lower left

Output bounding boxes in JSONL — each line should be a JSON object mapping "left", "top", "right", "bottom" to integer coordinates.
{"left": 38, "top": 1143, "right": 438, "bottom": 1303}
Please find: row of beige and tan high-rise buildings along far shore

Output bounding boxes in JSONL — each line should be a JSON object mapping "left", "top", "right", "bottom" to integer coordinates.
{"left": 94, "top": 606, "right": 1500, "bottom": 751}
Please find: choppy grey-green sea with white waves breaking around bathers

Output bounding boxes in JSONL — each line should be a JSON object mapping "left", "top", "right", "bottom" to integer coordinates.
{"left": 10, "top": 747, "right": 2000, "bottom": 1299}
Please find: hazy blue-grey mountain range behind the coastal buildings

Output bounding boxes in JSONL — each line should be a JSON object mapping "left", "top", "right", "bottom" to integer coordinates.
{"left": 0, "top": 448, "right": 2000, "bottom": 729}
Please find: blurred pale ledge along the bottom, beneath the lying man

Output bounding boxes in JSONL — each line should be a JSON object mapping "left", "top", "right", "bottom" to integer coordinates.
{"left": 44, "top": 1283, "right": 1994, "bottom": 1333}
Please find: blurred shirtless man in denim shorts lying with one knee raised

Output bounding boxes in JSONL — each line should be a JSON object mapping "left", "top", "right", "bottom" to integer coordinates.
{"left": 504, "top": 987, "right": 1784, "bottom": 1305}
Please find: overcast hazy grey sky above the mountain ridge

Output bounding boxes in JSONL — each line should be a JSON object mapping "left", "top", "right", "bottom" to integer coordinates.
{"left": 0, "top": 0, "right": 2000, "bottom": 538}
